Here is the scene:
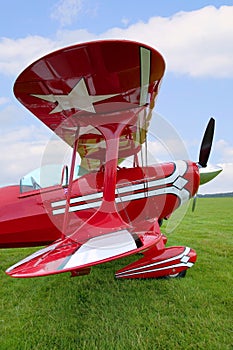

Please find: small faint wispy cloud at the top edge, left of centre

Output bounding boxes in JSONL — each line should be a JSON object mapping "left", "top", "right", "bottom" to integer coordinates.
{"left": 51, "top": 0, "right": 83, "bottom": 26}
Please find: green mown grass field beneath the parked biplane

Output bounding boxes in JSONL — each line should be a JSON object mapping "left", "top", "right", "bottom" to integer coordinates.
{"left": 0, "top": 198, "right": 233, "bottom": 350}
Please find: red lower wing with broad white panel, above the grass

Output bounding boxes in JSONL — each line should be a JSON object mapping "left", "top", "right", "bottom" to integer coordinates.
{"left": 6, "top": 221, "right": 162, "bottom": 278}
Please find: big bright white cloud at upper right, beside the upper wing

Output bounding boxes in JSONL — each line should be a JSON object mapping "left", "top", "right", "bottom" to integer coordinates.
{"left": 101, "top": 6, "right": 233, "bottom": 77}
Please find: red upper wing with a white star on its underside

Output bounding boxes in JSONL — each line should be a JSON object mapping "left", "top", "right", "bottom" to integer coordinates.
{"left": 14, "top": 40, "right": 165, "bottom": 170}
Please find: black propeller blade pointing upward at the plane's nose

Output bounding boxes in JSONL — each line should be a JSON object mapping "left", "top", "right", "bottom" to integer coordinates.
{"left": 198, "top": 118, "right": 215, "bottom": 168}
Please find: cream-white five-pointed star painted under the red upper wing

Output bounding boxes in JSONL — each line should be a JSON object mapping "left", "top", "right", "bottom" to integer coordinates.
{"left": 31, "top": 78, "right": 119, "bottom": 114}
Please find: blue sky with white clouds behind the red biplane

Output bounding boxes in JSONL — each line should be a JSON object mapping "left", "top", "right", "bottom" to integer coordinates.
{"left": 0, "top": 0, "right": 233, "bottom": 193}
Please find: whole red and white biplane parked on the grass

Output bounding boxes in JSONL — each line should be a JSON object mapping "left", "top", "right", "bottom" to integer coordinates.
{"left": 0, "top": 40, "right": 220, "bottom": 278}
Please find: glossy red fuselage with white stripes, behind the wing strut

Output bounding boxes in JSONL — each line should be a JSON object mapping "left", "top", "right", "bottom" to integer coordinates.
{"left": 0, "top": 161, "right": 199, "bottom": 248}
